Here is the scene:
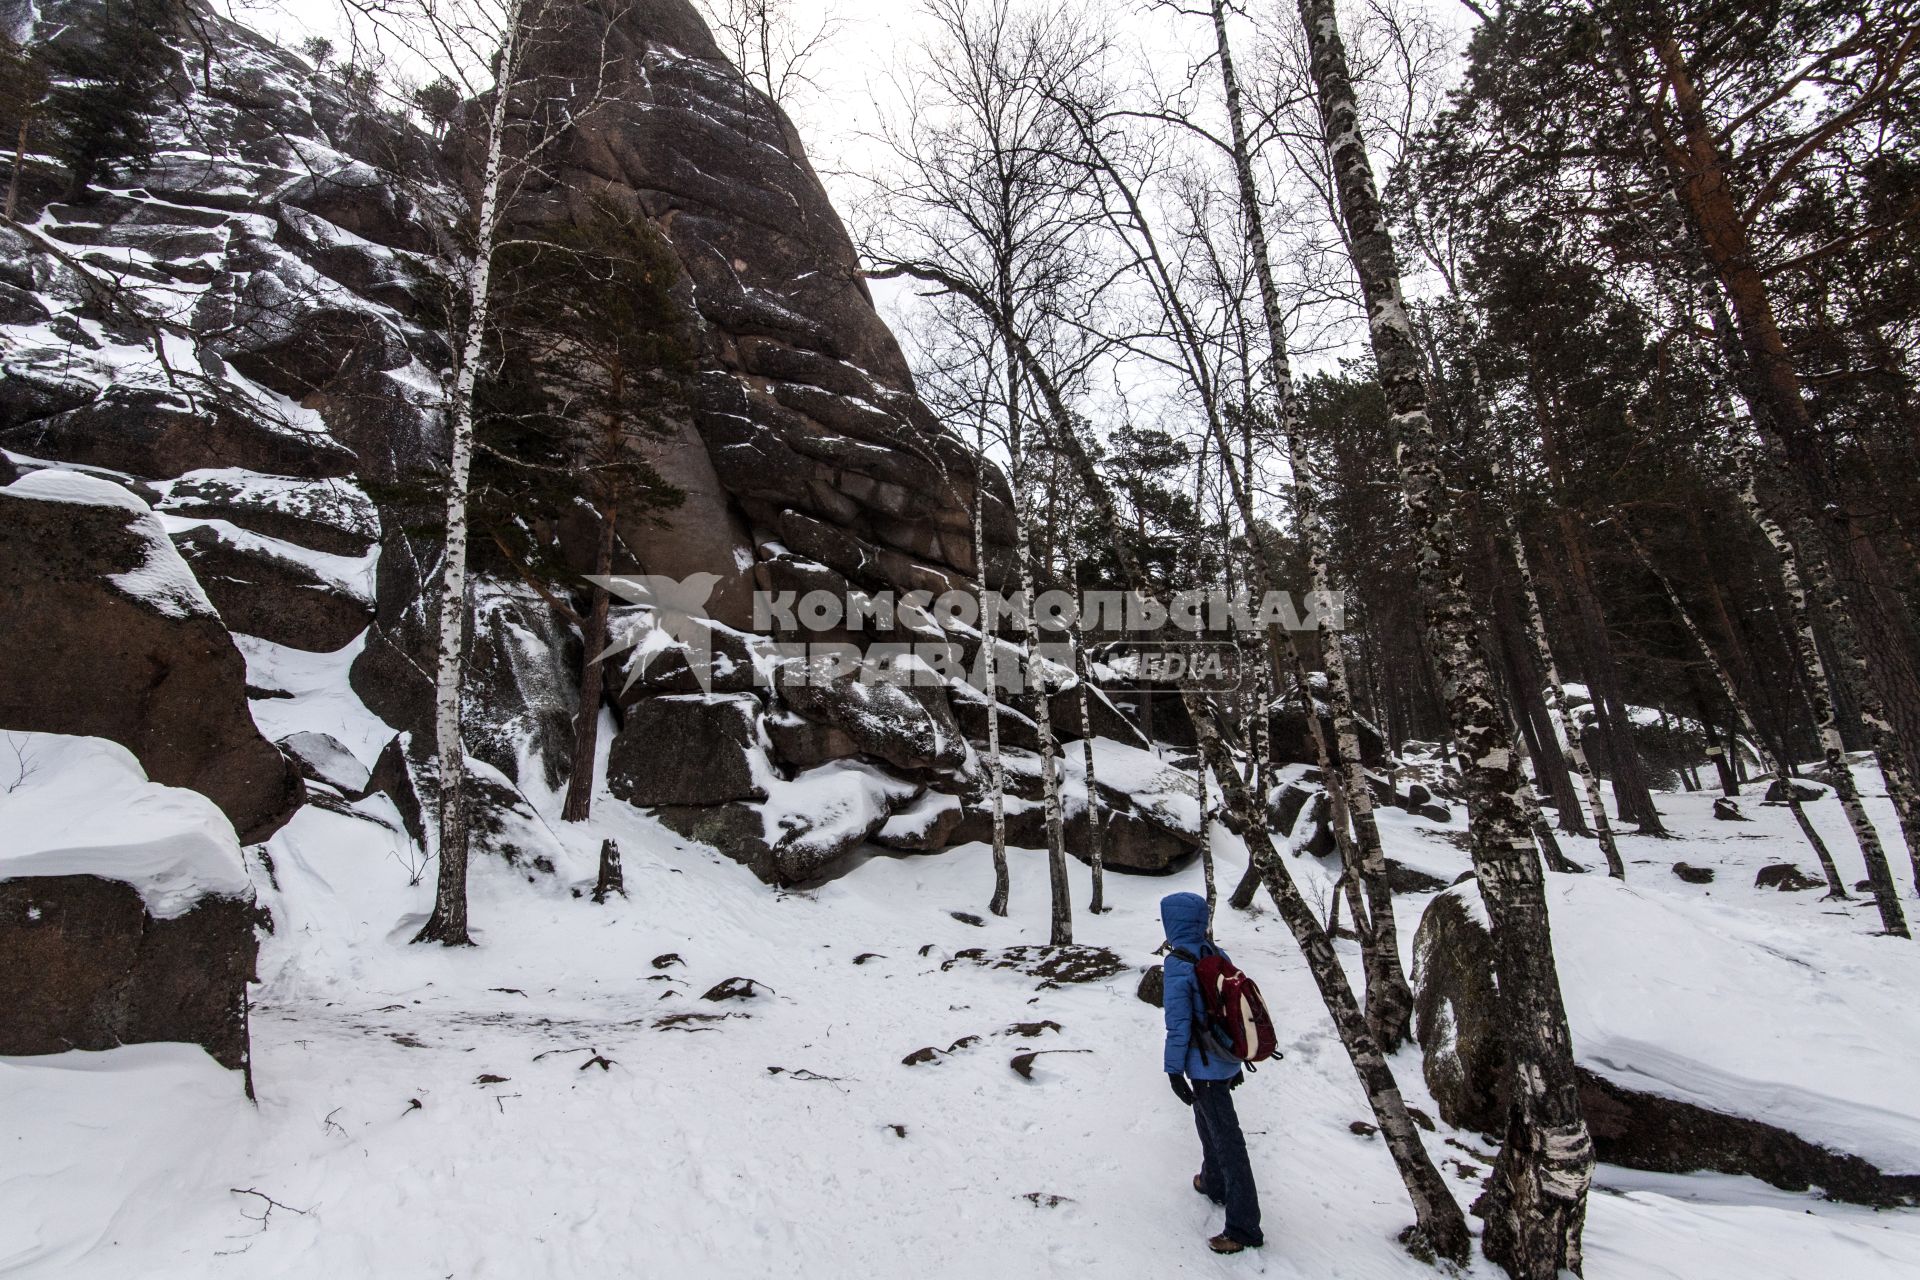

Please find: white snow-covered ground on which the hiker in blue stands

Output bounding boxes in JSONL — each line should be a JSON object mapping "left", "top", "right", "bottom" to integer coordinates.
{"left": 0, "top": 744, "right": 1920, "bottom": 1280}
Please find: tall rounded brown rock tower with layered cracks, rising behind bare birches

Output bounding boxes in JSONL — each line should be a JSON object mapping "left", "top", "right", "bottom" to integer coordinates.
{"left": 522, "top": 0, "right": 1010, "bottom": 626}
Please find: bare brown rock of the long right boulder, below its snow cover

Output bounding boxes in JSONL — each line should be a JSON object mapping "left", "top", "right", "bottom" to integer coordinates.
{"left": 1411, "top": 885, "right": 1920, "bottom": 1205}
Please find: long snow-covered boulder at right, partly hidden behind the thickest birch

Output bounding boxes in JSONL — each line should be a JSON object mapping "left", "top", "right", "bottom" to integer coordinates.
{"left": 1411, "top": 877, "right": 1920, "bottom": 1205}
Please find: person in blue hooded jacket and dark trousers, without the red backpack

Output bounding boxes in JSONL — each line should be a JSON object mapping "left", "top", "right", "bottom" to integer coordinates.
{"left": 1160, "top": 894, "right": 1265, "bottom": 1253}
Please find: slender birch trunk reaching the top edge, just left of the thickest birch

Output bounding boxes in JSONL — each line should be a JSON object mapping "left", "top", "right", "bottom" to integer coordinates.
{"left": 1213, "top": 0, "right": 1413, "bottom": 1052}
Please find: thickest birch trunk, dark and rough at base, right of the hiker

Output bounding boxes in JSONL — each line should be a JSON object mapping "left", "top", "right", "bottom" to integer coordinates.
{"left": 1300, "top": 0, "right": 1594, "bottom": 1258}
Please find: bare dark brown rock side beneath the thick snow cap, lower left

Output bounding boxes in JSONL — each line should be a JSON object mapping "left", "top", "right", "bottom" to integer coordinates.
{"left": 0, "top": 875, "right": 259, "bottom": 1069}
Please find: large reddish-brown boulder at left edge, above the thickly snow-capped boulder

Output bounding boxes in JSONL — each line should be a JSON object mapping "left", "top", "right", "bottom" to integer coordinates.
{"left": 0, "top": 470, "right": 303, "bottom": 842}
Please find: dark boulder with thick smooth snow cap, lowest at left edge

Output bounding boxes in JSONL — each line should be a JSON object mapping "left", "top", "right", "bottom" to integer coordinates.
{"left": 0, "top": 733, "right": 257, "bottom": 1069}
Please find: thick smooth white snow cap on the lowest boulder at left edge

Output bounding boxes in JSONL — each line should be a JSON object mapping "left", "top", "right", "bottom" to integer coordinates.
{"left": 0, "top": 731, "right": 253, "bottom": 919}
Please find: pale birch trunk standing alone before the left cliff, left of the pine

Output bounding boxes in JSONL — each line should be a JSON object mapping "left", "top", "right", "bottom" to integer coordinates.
{"left": 413, "top": 0, "right": 524, "bottom": 946}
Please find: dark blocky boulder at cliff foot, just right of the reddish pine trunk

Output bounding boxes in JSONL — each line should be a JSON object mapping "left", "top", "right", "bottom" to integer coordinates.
{"left": 607, "top": 693, "right": 774, "bottom": 805}
